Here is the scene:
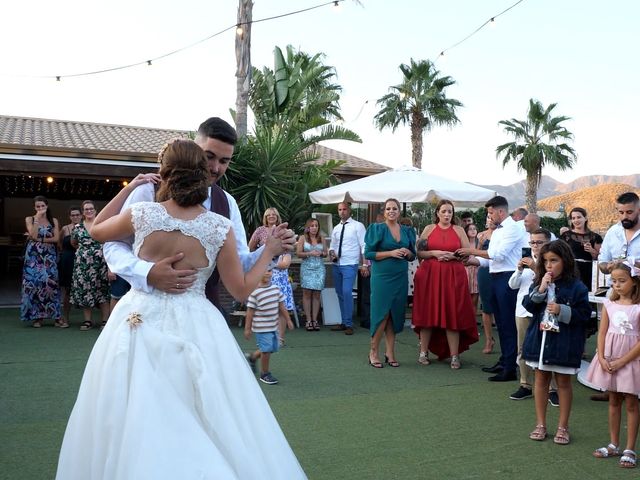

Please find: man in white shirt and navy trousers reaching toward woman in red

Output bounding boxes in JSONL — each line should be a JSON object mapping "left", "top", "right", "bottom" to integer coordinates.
{"left": 456, "top": 195, "right": 529, "bottom": 382}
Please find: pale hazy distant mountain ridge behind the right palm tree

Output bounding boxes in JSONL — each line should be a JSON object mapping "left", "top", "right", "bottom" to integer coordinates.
{"left": 480, "top": 174, "right": 640, "bottom": 207}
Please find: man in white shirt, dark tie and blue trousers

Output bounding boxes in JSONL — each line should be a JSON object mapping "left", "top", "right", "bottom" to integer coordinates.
{"left": 329, "top": 202, "right": 368, "bottom": 335}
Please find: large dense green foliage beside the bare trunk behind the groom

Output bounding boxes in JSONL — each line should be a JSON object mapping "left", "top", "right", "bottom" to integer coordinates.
{"left": 223, "top": 46, "right": 361, "bottom": 234}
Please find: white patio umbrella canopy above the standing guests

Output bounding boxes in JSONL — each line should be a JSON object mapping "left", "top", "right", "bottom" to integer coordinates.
{"left": 309, "top": 167, "right": 496, "bottom": 204}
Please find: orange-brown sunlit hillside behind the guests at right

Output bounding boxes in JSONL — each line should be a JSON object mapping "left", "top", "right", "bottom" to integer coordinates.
{"left": 538, "top": 183, "right": 640, "bottom": 235}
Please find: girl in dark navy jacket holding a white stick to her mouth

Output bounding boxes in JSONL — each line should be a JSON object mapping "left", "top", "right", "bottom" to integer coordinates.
{"left": 522, "top": 240, "right": 591, "bottom": 445}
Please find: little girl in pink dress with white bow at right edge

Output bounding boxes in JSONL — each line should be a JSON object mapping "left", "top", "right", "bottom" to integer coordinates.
{"left": 586, "top": 261, "right": 640, "bottom": 468}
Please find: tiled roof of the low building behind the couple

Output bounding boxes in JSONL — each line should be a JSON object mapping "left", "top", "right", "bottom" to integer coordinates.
{"left": 0, "top": 116, "right": 387, "bottom": 180}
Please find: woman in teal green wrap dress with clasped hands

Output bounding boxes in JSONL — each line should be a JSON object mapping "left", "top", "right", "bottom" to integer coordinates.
{"left": 364, "top": 198, "right": 416, "bottom": 368}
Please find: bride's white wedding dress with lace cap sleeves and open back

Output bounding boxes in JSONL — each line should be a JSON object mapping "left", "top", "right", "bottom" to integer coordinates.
{"left": 56, "top": 202, "right": 306, "bottom": 480}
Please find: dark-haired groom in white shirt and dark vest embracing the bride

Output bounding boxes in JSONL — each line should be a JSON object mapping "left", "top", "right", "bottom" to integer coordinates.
{"left": 103, "top": 117, "right": 295, "bottom": 309}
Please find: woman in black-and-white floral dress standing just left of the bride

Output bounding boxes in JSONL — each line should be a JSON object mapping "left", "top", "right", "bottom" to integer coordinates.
{"left": 71, "top": 200, "right": 110, "bottom": 330}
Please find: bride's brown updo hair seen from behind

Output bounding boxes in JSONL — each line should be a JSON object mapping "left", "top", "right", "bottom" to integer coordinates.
{"left": 156, "top": 139, "right": 211, "bottom": 207}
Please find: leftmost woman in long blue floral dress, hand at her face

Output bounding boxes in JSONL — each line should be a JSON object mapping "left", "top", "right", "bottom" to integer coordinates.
{"left": 20, "top": 195, "right": 63, "bottom": 328}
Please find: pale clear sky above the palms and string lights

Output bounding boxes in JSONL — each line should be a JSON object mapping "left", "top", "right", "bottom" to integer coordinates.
{"left": 0, "top": 0, "right": 640, "bottom": 185}
